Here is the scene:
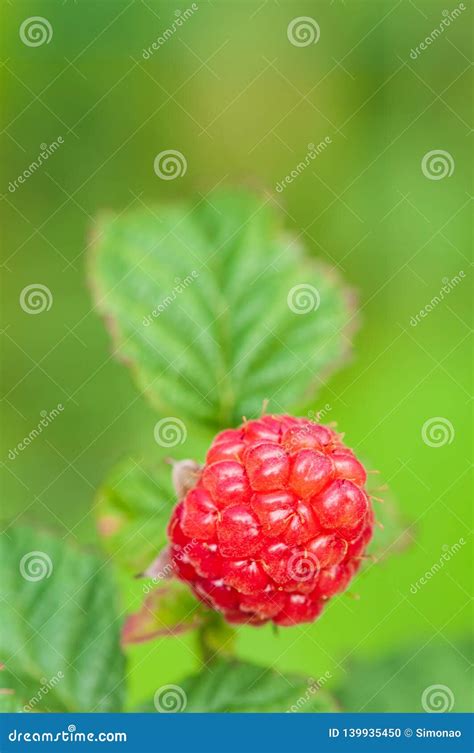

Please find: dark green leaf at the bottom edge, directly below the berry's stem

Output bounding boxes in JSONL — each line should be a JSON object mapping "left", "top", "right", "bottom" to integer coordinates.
{"left": 142, "top": 660, "right": 337, "bottom": 713}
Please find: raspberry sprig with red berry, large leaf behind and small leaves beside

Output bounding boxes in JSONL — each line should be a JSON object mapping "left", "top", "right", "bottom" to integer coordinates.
{"left": 89, "top": 189, "right": 401, "bottom": 711}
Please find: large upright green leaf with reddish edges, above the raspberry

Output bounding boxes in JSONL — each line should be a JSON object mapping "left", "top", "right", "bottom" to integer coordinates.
{"left": 90, "top": 190, "right": 353, "bottom": 426}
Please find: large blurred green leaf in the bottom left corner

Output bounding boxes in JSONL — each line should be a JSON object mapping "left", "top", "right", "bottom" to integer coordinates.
{"left": 0, "top": 528, "right": 124, "bottom": 712}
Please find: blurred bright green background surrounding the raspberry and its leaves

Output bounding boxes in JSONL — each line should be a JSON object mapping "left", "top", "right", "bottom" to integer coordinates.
{"left": 0, "top": 0, "right": 472, "bottom": 711}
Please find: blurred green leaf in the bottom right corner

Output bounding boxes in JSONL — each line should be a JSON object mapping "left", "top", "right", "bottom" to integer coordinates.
{"left": 336, "top": 639, "right": 474, "bottom": 713}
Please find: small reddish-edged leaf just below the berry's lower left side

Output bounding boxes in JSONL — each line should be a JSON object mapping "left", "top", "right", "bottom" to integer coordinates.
{"left": 122, "top": 580, "right": 204, "bottom": 644}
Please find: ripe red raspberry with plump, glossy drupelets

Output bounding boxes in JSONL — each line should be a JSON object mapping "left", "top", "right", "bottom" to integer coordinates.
{"left": 168, "top": 416, "right": 374, "bottom": 625}
